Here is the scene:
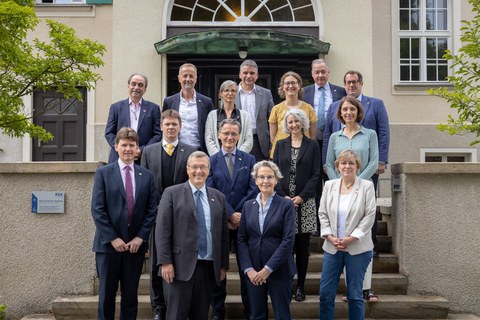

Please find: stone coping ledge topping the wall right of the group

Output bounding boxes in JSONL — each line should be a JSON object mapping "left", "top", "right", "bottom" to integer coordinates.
{"left": 390, "top": 162, "right": 480, "bottom": 174}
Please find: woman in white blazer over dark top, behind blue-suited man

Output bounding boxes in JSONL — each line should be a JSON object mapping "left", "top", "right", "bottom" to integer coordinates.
{"left": 205, "top": 80, "right": 253, "bottom": 155}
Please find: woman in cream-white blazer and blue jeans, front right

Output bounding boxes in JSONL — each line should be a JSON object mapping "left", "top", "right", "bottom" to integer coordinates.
{"left": 318, "top": 150, "right": 376, "bottom": 320}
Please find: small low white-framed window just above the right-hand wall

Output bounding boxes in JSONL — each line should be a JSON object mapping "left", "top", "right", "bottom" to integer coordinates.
{"left": 420, "top": 148, "right": 477, "bottom": 162}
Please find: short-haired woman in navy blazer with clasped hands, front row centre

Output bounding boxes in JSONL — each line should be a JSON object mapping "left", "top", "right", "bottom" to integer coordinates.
{"left": 238, "top": 161, "right": 295, "bottom": 320}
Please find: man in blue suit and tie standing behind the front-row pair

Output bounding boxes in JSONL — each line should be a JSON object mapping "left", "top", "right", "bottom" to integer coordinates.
{"left": 207, "top": 119, "right": 258, "bottom": 320}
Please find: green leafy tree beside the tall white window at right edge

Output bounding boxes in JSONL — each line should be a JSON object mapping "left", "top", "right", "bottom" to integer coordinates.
{"left": 429, "top": 0, "right": 480, "bottom": 145}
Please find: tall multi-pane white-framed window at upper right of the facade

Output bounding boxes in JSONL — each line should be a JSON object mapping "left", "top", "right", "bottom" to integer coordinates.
{"left": 398, "top": 0, "right": 452, "bottom": 83}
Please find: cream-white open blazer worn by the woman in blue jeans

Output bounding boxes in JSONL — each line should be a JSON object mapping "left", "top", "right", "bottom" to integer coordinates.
{"left": 318, "top": 177, "right": 376, "bottom": 255}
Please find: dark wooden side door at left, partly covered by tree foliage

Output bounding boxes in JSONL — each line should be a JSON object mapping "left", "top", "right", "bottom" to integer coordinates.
{"left": 32, "top": 88, "right": 87, "bottom": 161}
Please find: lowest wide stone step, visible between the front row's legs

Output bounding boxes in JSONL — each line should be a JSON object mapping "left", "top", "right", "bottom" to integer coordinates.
{"left": 52, "top": 295, "right": 449, "bottom": 320}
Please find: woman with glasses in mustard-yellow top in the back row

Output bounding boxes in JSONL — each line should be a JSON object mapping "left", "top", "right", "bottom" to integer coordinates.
{"left": 268, "top": 71, "right": 318, "bottom": 158}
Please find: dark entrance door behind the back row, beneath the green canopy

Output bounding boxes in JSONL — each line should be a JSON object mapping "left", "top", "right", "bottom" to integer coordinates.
{"left": 167, "top": 55, "right": 318, "bottom": 106}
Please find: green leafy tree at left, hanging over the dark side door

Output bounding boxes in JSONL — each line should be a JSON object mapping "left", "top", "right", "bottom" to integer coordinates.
{"left": 0, "top": 0, "right": 105, "bottom": 141}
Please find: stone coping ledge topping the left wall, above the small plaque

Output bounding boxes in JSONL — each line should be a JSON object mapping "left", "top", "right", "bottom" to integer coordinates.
{"left": 0, "top": 161, "right": 104, "bottom": 174}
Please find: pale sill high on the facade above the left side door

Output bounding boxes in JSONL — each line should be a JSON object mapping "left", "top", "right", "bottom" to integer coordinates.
{"left": 35, "top": 4, "right": 95, "bottom": 18}
